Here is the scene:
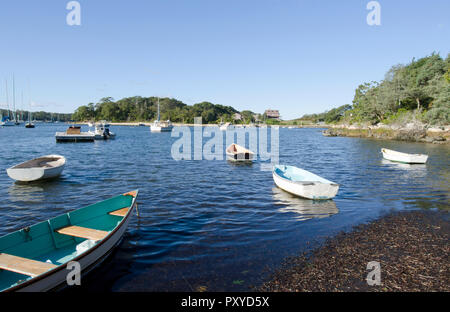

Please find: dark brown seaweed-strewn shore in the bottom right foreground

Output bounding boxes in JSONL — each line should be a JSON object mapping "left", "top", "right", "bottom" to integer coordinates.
{"left": 258, "top": 211, "right": 450, "bottom": 292}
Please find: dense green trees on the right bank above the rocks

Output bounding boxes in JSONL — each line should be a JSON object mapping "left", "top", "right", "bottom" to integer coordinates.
{"left": 299, "top": 53, "right": 450, "bottom": 125}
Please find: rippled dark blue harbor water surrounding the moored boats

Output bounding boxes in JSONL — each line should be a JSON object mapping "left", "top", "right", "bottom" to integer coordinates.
{"left": 0, "top": 124, "right": 450, "bottom": 291}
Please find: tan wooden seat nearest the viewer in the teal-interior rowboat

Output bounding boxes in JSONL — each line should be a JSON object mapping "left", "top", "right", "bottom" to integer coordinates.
{"left": 0, "top": 253, "right": 57, "bottom": 277}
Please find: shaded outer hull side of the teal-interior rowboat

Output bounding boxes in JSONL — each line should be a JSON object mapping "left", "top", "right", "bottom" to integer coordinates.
{"left": 11, "top": 202, "right": 135, "bottom": 292}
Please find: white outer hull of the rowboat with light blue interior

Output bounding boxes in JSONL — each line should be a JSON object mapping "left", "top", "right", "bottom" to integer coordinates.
{"left": 273, "top": 168, "right": 339, "bottom": 200}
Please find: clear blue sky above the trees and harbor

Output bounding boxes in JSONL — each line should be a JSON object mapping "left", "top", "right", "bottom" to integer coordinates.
{"left": 0, "top": 0, "right": 450, "bottom": 119}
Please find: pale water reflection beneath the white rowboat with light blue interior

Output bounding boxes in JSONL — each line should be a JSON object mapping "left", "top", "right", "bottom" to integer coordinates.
{"left": 272, "top": 187, "right": 339, "bottom": 221}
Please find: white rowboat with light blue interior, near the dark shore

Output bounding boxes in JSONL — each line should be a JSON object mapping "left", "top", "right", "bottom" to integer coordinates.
{"left": 273, "top": 165, "right": 339, "bottom": 199}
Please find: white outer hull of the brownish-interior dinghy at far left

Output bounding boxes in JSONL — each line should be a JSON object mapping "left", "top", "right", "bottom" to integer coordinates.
{"left": 6, "top": 155, "right": 66, "bottom": 182}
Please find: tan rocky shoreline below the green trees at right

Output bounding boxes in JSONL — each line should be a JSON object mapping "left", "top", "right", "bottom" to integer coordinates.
{"left": 323, "top": 123, "right": 450, "bottom": 144}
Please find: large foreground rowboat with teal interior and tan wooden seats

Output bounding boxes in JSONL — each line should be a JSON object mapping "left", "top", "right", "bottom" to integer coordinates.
{"left": 0, "top": 191, "right": 138, "bottom": 292}
